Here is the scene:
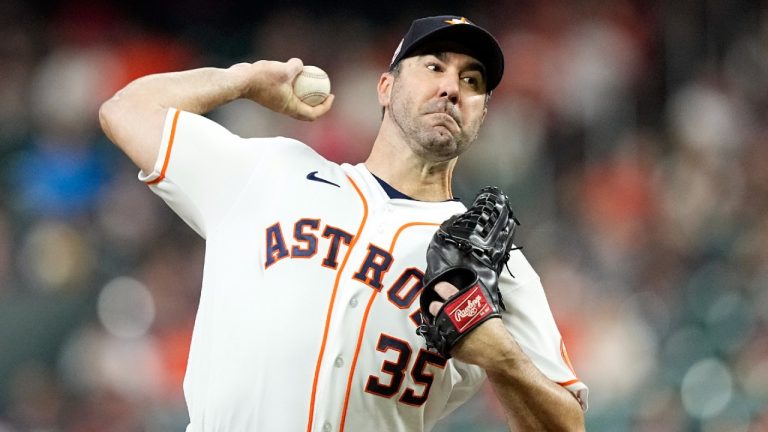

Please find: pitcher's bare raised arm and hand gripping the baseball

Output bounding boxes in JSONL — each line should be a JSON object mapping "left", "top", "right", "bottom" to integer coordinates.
{"left": 99, "top": 58, "right": 333, "bottom": 172}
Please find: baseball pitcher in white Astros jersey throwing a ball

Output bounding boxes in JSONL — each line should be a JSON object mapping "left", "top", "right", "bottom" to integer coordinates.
{"left": 100, "top": 16, "right": 587, "bottom": 432}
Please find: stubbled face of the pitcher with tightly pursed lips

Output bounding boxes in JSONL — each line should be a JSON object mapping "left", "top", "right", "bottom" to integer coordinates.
{"left": 387, "top": 52, "right": 486, "bottom": 162}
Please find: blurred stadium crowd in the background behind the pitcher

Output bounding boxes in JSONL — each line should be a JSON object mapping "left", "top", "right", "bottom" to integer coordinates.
{"left": 0, "top": 0, "right": 768, "bottom": 432}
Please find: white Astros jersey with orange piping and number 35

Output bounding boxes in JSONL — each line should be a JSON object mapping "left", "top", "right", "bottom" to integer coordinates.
{"left": 139, "top": 109, "right": 587, "bottom": 432}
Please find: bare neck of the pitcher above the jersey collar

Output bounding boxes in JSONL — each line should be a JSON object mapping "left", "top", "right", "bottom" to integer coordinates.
{"left": 365, "top": 125, "right": 457, "bottom": 201}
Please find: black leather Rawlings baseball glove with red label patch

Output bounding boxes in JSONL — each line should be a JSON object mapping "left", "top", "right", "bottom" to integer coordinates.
{"left": 417, "top": 186, "right": 520, "bottom": 358}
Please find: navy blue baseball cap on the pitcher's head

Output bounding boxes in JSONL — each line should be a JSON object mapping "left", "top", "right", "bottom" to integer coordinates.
{"left": 389, "top": 15, "right": 504, "bottom": 93}
